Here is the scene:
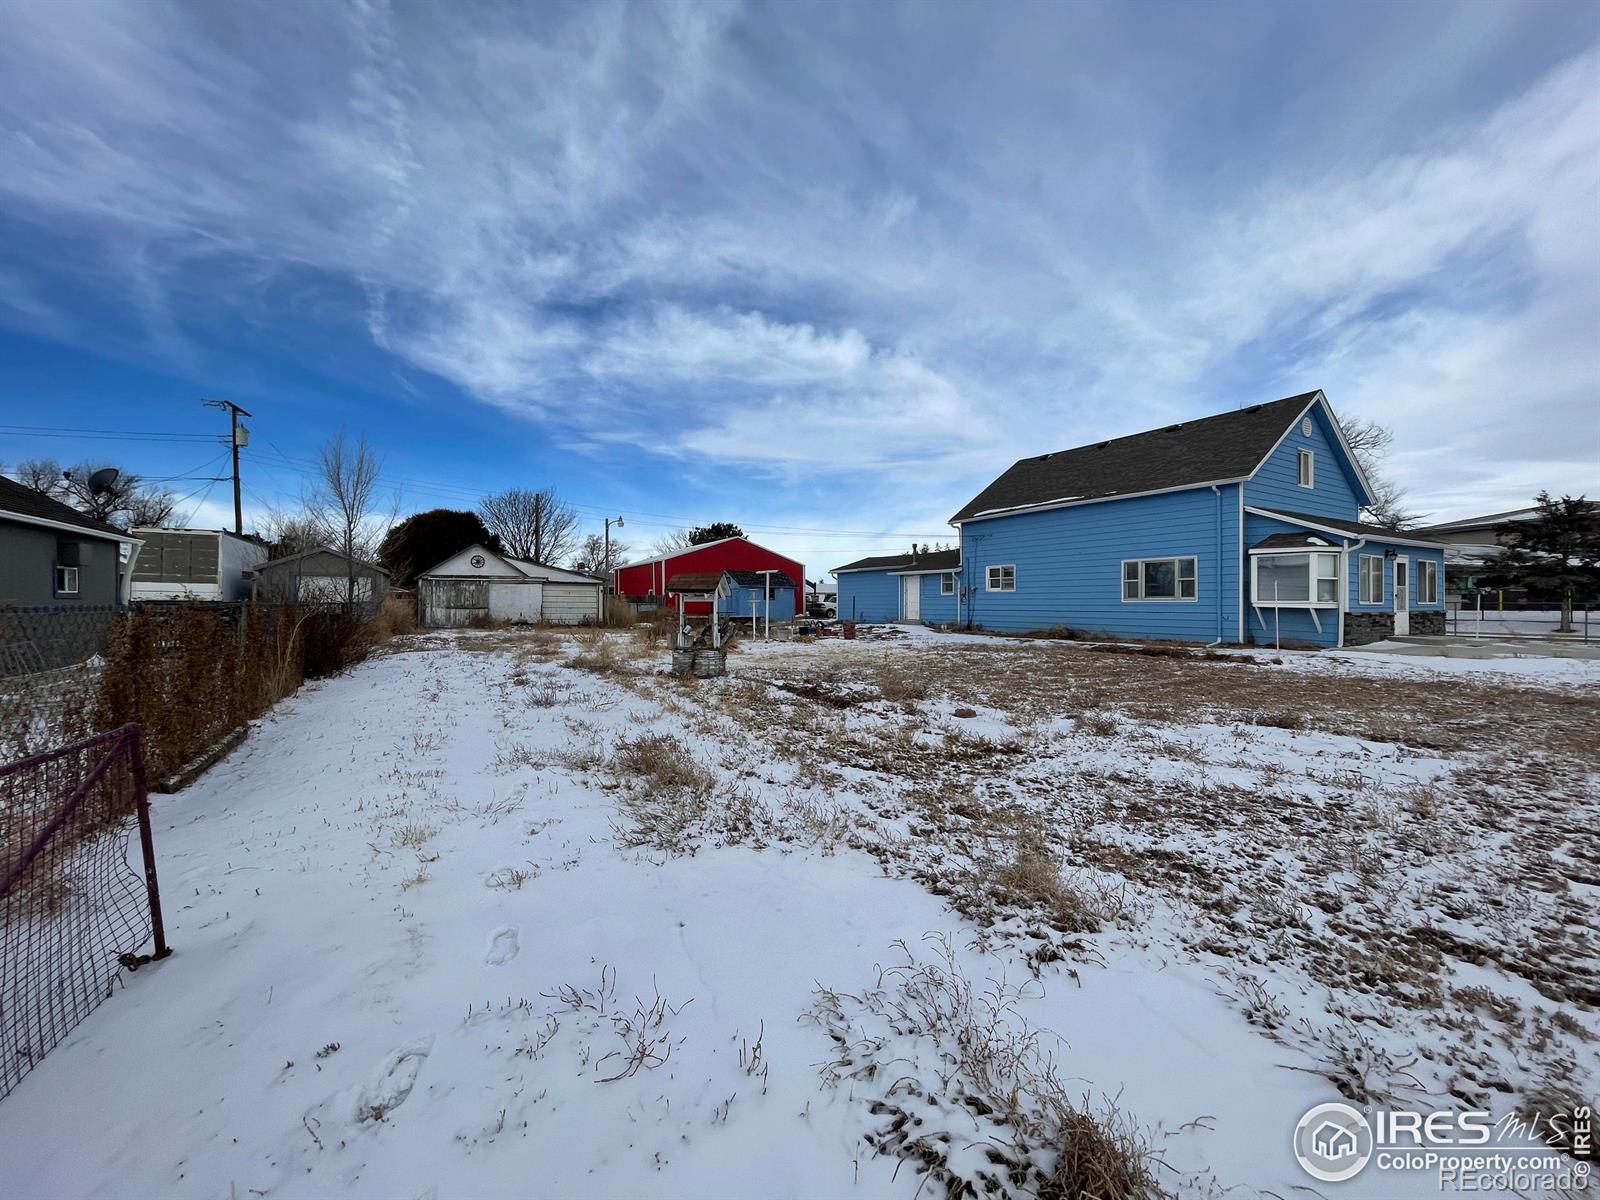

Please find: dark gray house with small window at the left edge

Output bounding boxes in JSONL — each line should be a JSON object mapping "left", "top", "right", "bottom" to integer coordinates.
{"left": 0, "top": 477, "right": 139, "bottom": 608}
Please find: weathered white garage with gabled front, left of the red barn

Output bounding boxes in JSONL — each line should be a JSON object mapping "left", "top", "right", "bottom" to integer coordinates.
{"left": 416, "top": 546, "right": 605, "bottom": 629}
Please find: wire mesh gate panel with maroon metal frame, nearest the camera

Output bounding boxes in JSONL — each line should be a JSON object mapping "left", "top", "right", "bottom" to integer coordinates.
{"left": 0, "top": 725, "right": 168, "bottom": 1099}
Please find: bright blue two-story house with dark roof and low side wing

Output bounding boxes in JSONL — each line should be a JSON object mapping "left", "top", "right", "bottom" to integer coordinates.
{"left": 835, "top": 392, "right": 1445, "bottom": 646}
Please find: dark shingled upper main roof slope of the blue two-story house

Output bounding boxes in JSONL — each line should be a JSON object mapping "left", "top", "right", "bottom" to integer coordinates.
{"left": 950, "top": 392, "right": 1317, "bottom": 522}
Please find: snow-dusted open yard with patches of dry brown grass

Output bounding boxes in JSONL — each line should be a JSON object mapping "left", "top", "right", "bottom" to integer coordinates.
{"left": 0, "top": 630, "right": 1600, "bottom": 1198}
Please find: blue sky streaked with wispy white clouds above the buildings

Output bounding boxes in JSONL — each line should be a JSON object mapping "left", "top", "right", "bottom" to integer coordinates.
{"left": 0, "top": 0, "right": 1600, "bottom": 568}
